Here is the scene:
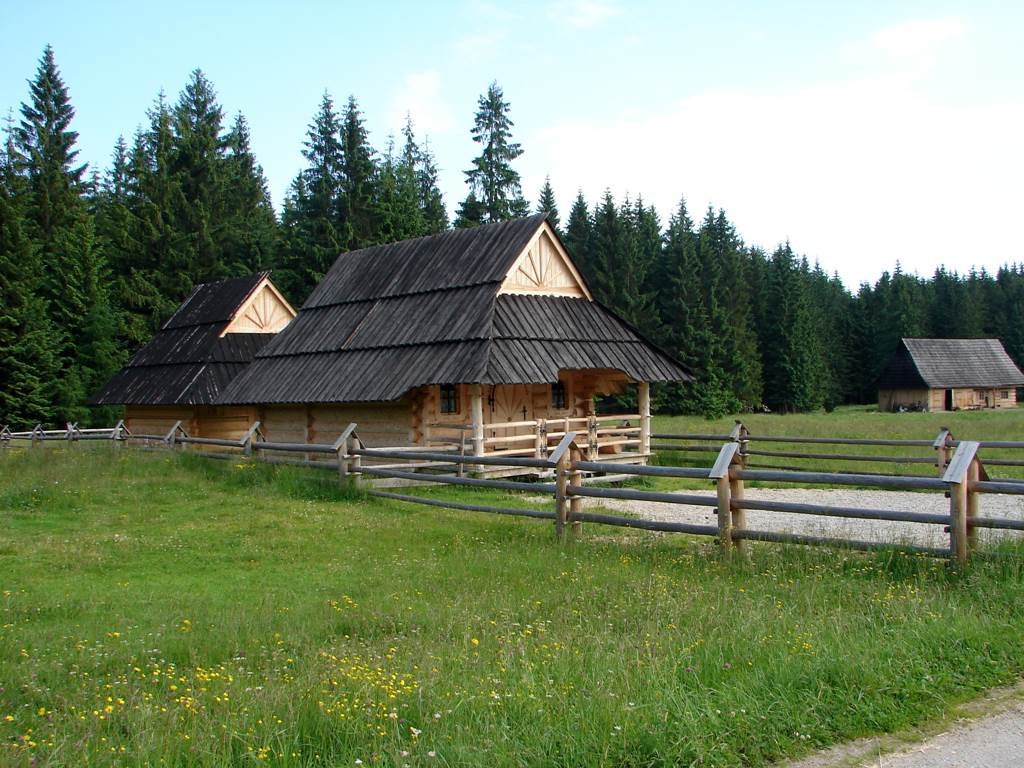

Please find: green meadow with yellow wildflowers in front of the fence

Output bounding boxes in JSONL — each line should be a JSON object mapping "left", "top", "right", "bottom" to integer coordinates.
{"left": 0, "top": 448, "right": 1024, "bottom": 766}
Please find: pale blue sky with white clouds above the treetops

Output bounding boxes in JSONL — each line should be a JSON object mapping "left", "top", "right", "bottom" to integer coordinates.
{"left": 0, "top": 0, "right": 1024, "bottom": 290}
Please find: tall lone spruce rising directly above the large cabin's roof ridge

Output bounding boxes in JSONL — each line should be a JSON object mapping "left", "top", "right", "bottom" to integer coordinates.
{"left": 460, "top": 82, "right": 529, "bottom": 225}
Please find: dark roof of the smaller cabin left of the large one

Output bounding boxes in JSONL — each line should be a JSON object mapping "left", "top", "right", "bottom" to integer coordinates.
{"left": 90, "top": 272, "right": 273, "bottom": 406}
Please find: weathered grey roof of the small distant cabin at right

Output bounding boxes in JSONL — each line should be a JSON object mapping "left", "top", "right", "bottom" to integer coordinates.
{"left": 879, "top": 339, "right": 1024, "bottom": 389}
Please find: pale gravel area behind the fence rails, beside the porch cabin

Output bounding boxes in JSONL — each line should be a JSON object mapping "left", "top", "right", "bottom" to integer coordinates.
{"left": 587, "top": 487, "right": 1024, "bottom": 548}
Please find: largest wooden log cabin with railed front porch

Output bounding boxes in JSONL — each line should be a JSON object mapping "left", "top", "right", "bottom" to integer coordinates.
{"left": 218, "top": 215, "right": 691, "bottom": 462}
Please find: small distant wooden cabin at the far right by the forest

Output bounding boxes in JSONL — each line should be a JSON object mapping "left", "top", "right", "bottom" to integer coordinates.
{"left": 879, "top": 339, "right": 1024, "bottom": 411}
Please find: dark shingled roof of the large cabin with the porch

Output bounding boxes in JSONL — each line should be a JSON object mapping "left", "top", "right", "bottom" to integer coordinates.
{"left": 219, "top": 215, "right": 691, "bottom": 404}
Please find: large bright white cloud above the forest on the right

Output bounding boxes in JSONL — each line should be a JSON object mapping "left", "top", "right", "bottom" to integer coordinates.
{"left": 523, "top": 71, "right": 1024, "bottom": 288}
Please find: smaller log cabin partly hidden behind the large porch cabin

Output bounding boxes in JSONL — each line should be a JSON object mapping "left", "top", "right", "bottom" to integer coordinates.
{"left": 91, "top": 272, "right": 295, "bottom": 437}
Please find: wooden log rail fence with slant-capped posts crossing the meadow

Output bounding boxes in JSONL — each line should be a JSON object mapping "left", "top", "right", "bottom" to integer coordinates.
{"left": 6, "top": 422, "right": 1024, "bottom": 563}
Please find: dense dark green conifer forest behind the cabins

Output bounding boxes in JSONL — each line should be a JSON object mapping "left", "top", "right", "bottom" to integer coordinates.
{"left": 0, "top": 47, "right": 1024, "bottom": 426}
